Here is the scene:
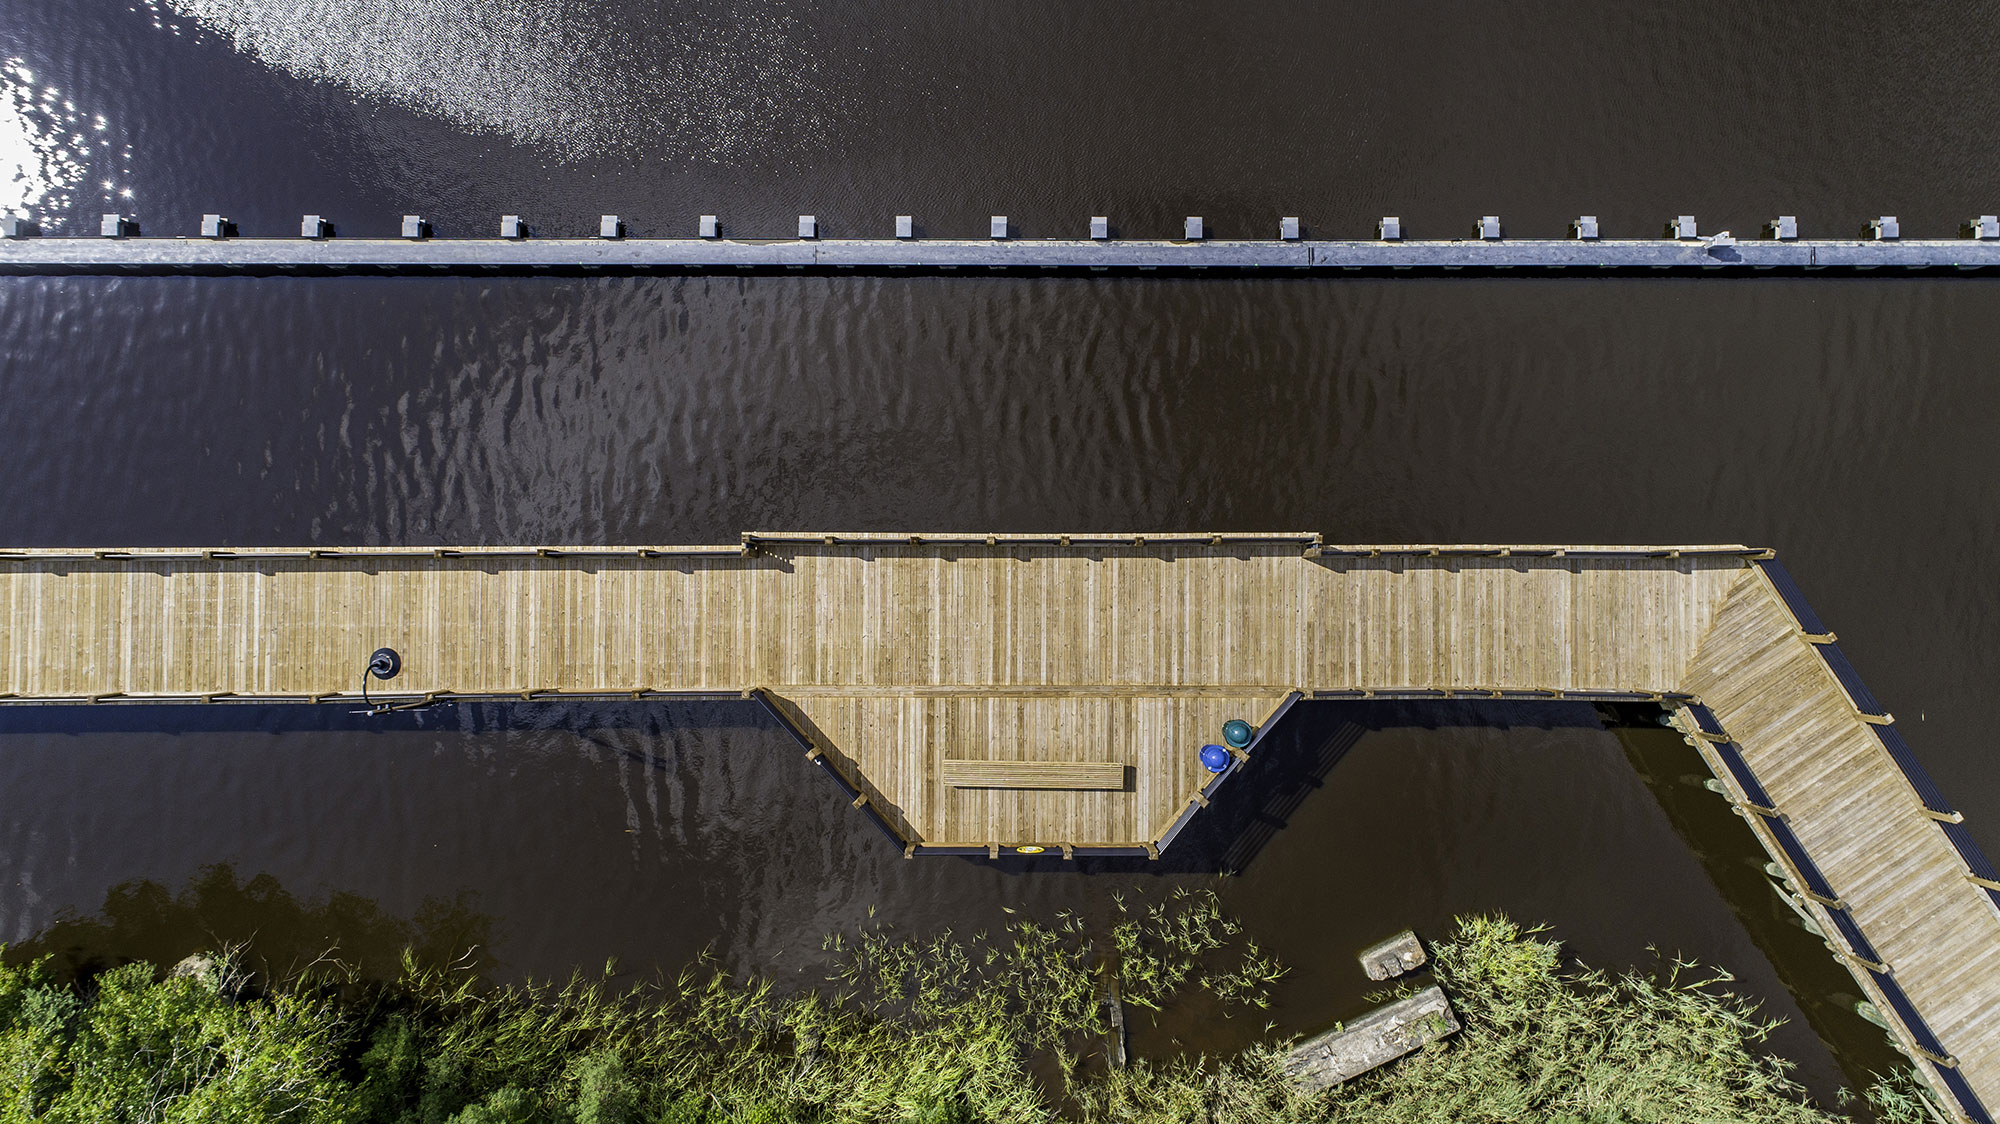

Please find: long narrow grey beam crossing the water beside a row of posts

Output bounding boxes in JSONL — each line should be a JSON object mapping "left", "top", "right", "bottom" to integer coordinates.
{"left": 11, "top": 230, "right": 2000, "bottom": 276}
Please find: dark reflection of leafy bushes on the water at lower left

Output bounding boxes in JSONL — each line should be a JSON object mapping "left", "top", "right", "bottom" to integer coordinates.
{"left": 6, "top": 864, "right": 494, "bottom": 980}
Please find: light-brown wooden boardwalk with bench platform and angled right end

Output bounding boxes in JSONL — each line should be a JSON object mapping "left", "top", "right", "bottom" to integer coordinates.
{"left": 0, "top": 534, "right": 2000, "bottom": 1120}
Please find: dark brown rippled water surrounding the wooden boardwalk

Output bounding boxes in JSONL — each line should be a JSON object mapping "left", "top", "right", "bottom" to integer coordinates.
{"left": 0, "top": 0, "right": 2000, "bottom": 1094}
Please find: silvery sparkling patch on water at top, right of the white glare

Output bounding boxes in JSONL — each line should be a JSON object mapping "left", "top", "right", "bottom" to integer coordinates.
{"left": 146, "top": 0, "right": 832, "bottom": 162}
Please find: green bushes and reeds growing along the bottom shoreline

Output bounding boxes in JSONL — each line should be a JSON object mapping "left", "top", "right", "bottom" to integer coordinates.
{"left": 0, "top": 894, "right": 1924, "bottom": 1124}
